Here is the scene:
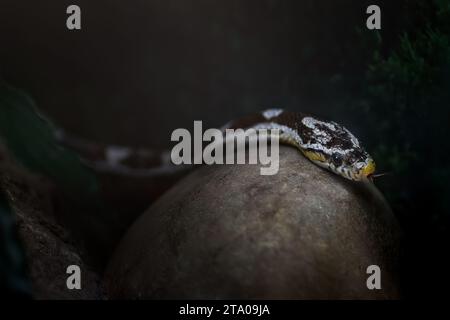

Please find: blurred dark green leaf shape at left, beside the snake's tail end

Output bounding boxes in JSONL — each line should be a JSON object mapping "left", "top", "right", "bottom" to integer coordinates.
{"left": 0, "top": 83, "right": 98, "bottom": 198}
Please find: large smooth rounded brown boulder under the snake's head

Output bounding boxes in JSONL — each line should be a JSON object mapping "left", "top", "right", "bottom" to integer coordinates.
{"left": 105, "top": 147, "right": 399, "bottom": 299}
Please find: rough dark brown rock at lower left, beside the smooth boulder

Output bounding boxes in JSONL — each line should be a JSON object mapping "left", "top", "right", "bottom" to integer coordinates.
{"left": 0, "top": 143, "right": 105, "bottom": 299}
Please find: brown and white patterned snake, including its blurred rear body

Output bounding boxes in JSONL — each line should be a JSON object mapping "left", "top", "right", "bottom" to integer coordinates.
{"left": 58, "top": 108, "right": 376, "bottom": 181}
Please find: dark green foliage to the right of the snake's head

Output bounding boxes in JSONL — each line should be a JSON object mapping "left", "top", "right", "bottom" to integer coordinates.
{"left": 363, "top": 0, "right": 450, "bottom": 228}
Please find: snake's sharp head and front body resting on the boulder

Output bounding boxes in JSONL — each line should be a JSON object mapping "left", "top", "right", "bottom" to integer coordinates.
{"left": 225, "top": 109, "right": 376, "bottom": 181}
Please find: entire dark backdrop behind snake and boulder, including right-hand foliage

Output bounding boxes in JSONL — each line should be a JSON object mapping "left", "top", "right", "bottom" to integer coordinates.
{"left": 0, "top": 0, "right": 450, "bottom": 297}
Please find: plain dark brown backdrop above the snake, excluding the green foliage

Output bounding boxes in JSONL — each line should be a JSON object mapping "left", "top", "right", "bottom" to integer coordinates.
{"left": 0, "top": 0, "right": 402, "bottom": 147}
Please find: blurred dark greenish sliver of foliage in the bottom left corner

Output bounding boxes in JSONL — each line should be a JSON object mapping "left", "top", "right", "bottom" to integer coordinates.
{"left": 0, "top": 191, "right": 31, "bottom": 297}
